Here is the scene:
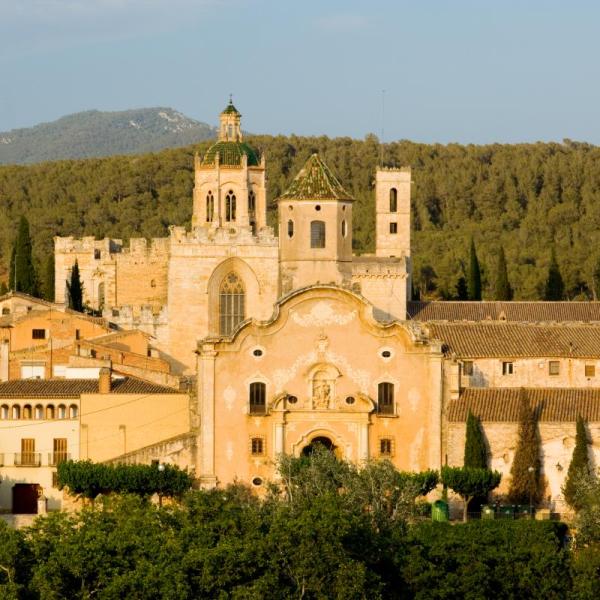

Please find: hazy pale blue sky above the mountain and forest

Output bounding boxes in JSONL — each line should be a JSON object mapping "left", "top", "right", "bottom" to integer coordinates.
{"left": 0, "top": 0, "right": 600, "bottom": 144}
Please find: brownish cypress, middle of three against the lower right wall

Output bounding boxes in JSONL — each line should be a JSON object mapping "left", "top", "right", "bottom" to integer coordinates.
{"left": 508, "top": 391, "right": 542, "bottom": 505}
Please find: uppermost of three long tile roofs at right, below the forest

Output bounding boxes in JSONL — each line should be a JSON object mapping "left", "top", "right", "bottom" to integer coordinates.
{"left": 406, "top": 302, "right": 600, "bottom": 323}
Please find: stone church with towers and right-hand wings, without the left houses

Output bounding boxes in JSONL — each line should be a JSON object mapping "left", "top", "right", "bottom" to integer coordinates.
{"left": 55, "top": 102, "right": 600, "bottom": 504}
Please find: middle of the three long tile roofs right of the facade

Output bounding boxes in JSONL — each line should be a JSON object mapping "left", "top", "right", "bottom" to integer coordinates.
{"left": 426, "top": 322, "right": 600, "bottom": 358}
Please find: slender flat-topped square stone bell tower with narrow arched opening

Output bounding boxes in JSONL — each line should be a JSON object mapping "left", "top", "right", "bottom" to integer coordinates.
{"left": 375, "top": 167, "right": 411, "bottom": 259}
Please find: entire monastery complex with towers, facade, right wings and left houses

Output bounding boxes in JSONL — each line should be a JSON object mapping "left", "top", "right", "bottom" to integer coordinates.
{"left": 0, "top": 102, "right": 600, "bottom": 511}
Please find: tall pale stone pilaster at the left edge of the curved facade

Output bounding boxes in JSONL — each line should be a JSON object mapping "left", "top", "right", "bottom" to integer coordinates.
{"left": 196, "top": 344, "right": 217, "bottom": 488}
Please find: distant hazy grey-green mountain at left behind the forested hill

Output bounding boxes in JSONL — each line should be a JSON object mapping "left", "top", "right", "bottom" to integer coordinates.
{"left": 0, "top": 107, "right": 216, "bottom": 164}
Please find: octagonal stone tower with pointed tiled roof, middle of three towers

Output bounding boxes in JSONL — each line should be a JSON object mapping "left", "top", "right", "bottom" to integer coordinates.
{"left": 277, "top": 154, "right": 354, "bottom": 293}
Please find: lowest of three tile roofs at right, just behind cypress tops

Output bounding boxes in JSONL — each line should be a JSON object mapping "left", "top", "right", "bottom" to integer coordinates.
{"left": 448, "top": 388, "right": 600, "bottom": 423}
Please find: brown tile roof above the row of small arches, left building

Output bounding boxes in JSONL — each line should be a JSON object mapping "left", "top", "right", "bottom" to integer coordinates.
{"left": 0, "top": 377, "right": 178, "bottom": 399}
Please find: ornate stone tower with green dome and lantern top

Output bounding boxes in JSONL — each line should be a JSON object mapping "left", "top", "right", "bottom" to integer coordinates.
{"left": 192, "top": 100, "right": 267, "bottom": 233}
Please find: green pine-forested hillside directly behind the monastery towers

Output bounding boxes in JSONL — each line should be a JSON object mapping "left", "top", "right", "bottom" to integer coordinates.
{"left": 0, "top": 136, "right": 600, "bottom": 299}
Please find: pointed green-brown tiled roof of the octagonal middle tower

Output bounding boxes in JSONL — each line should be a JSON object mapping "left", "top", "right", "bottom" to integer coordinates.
{"left": 278, "top": 154, "right": 354, "bottom": 200}
